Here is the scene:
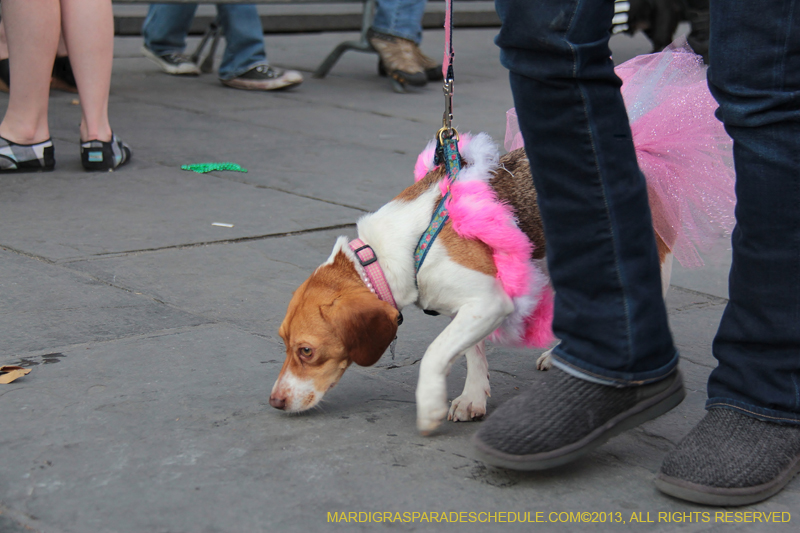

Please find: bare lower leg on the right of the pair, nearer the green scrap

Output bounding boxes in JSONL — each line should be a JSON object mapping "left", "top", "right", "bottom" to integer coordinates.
{"left": 60, "top": 0, "right": 114, "bottom": 142}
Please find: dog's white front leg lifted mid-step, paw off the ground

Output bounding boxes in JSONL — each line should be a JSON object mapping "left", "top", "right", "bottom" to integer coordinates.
{"left": 417, "top": 297, "right": 514, "bottom": 435}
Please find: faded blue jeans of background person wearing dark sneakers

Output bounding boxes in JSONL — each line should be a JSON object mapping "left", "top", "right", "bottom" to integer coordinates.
{"left": 142, "top": 4, "right": 268, "bottom": 80}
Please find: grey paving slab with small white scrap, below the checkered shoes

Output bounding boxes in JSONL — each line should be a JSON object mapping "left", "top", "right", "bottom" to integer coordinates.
{"left": 0, "top": 166, "right": 361, "bottom": 260}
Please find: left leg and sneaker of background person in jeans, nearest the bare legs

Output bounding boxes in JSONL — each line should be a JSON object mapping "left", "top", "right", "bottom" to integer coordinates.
{"left": 142, "top": 4, "right": 200, "bottom": 76}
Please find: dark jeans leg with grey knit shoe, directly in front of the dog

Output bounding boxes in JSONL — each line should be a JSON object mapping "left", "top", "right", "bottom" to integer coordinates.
{"left": 475, "top": 0, "right": 684, "bottom": 469}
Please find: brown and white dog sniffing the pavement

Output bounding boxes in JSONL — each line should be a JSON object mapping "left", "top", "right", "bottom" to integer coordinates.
{"left": 270, "top": 132, "right": 671, "bottom": 434}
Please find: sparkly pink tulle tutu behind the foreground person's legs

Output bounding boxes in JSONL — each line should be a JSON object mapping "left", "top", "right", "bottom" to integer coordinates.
{"left": 505, "top": 44, "right": 736, "bottom": 267}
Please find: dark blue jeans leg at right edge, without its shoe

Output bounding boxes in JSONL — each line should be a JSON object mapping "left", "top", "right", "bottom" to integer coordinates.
{"left": 706, "top": 0, "right": 800, "bottom": 424}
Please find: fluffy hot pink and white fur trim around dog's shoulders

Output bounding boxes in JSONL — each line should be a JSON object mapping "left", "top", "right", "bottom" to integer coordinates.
{"left": 414, "top": 133, "right": 555, "bottom": 348}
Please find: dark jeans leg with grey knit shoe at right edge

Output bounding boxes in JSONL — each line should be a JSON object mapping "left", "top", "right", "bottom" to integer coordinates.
{"left": 657, "top": 0, "right": 800, "bottom": 505}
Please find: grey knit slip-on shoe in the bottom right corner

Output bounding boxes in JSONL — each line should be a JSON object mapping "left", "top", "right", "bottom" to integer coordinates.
{"left": 656, "top": 408, "right": 800, "bottom": 507}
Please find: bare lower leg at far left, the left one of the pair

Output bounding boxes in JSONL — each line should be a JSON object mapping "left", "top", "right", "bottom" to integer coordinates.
{"left": 0, "top": 0, "right": 61, "bottom": 144}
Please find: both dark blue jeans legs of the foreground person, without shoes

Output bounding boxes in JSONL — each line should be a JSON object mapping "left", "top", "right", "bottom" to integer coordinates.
{"left": 496, "top": 0, "right": 800, "bottom": 424}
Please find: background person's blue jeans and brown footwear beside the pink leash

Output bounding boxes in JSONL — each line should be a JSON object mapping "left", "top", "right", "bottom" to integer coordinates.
{"left": 370, "top": 0, "right": 442, "bottom": 86}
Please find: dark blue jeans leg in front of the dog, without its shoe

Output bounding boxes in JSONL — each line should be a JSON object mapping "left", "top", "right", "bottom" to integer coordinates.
{"left": 496, "top": 0, "right": 678, "bottom": 386}
